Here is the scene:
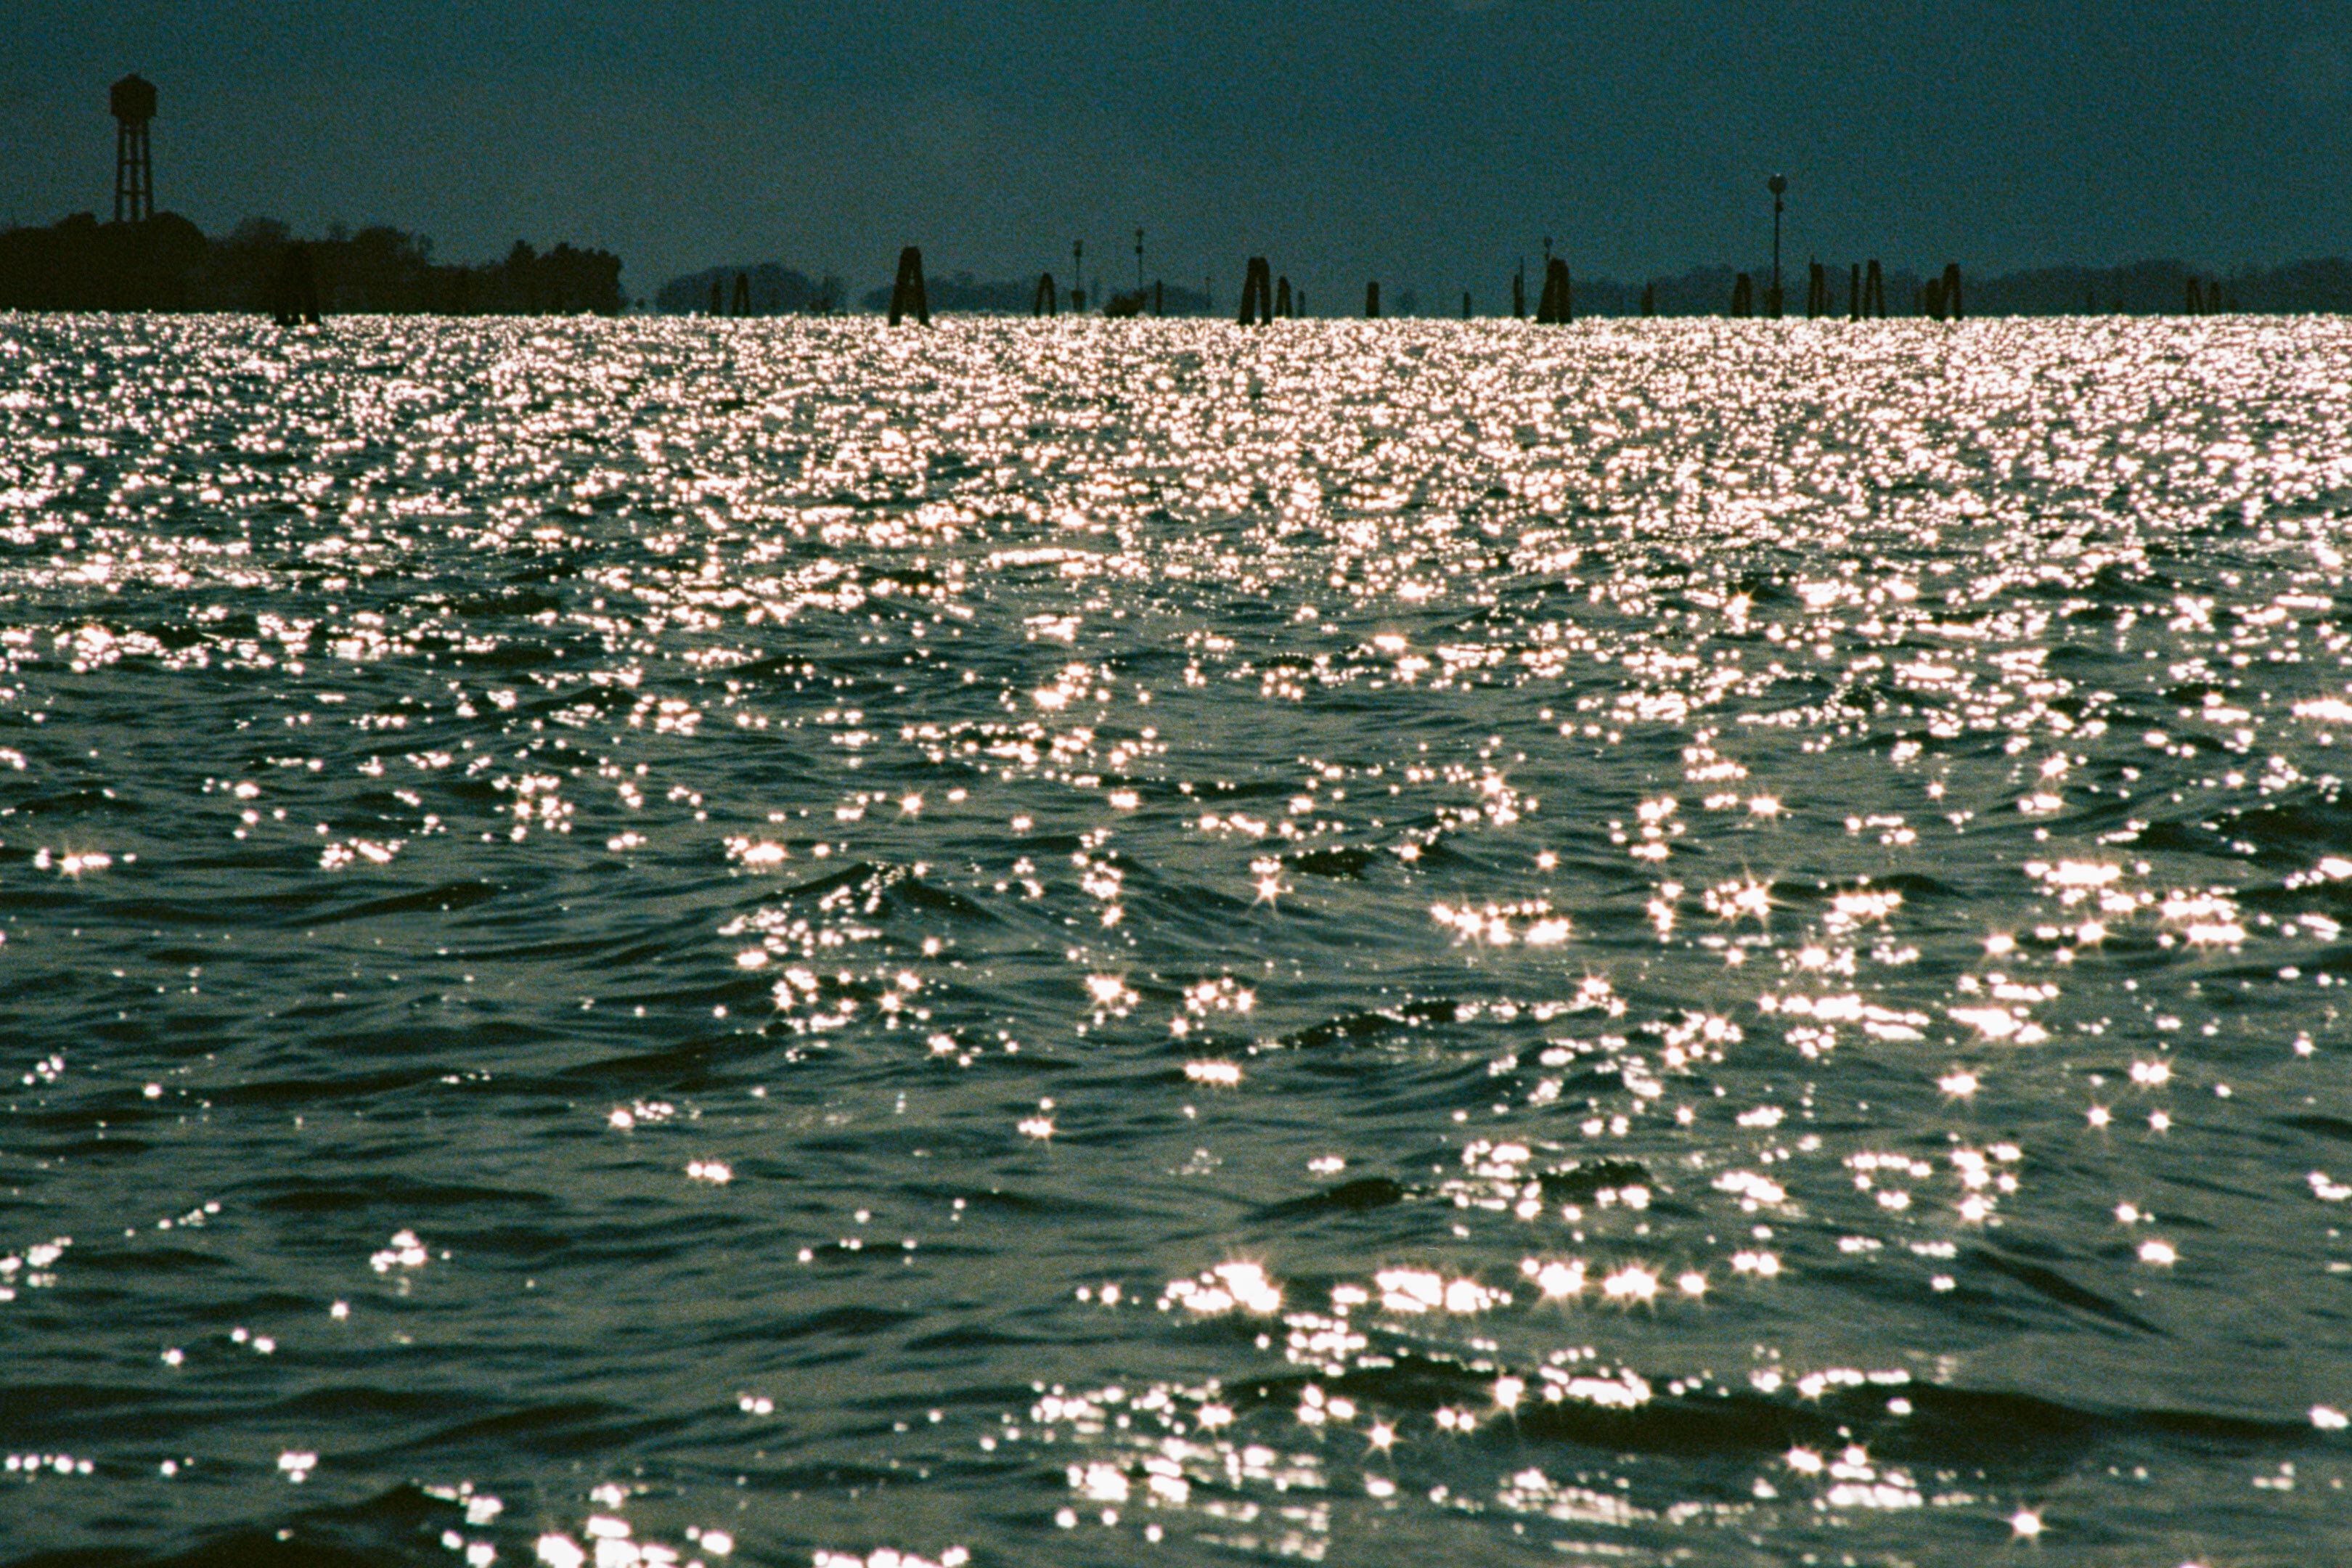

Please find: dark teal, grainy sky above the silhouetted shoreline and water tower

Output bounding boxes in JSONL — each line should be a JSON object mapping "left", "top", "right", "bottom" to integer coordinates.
{"left": 0, "top": 0, "right": 2352, "bottom": 303}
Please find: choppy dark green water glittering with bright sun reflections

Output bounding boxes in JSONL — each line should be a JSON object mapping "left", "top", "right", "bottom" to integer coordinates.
{"left": 0, "top": 317, "right": 2352, "bottom": 1568}
